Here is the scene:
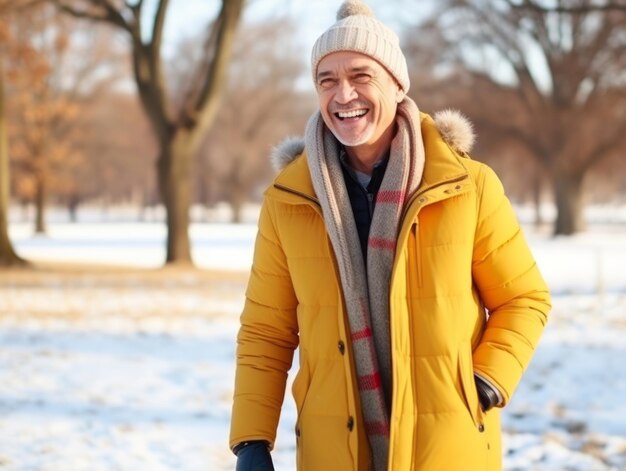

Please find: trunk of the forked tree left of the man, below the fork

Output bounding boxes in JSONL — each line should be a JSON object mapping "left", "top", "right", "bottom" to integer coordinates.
{"left": 157, "top": 130, "right": 192, "bottom": 265}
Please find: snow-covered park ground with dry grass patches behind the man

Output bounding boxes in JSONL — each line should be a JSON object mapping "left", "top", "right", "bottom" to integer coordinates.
{"left": 0, "top": 215, "right": 626, "bottom": 471}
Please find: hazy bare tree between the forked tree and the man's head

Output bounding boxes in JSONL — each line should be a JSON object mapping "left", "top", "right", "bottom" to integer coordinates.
{"left": 200, "top": 19, "right": 312, "bottom": 222}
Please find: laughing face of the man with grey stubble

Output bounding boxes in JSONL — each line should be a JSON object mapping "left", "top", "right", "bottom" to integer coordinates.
{"left": 316, "top": 51, "right": 403, "bottom": 155}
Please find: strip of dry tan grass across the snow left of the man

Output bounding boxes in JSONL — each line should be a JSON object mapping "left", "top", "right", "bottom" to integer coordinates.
{"left": 0, "top": 263, "right": 248, "bottom": 321}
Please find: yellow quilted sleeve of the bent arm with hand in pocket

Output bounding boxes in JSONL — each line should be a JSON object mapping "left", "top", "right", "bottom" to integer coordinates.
{"left": 472, "top": 166, "right": 551, "bottom": 405}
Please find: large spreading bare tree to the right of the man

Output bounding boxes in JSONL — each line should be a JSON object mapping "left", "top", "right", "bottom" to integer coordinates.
{"left": 410, "top": 0, "right": 626, "bottom": 235}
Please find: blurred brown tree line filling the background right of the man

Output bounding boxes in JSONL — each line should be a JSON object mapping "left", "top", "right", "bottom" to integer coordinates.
{"left": 405, "top": 0, "right": 626, "bottom": 235}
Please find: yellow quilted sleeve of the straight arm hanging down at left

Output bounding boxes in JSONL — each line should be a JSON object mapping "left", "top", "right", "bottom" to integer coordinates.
{"left": 230, "top": 199, "right": 298, "bottom": 448}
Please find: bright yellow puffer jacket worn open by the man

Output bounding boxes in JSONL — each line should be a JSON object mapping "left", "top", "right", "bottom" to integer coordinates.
{"left": 230, "top": 115, "right": 550, "bottom": 471}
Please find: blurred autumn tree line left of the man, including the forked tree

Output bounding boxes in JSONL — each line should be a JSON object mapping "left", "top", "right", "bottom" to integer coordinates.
{"left": 0, "top": 0, "right": 310, "bottom": 263}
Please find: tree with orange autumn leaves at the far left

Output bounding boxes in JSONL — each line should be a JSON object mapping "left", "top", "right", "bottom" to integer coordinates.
{"left": 5, "top": 2, "right": 126, "bottom": 233}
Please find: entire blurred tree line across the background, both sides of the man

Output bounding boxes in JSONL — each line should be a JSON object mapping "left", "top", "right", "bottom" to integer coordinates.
{"left": 0, "top": 0, "right": 626, "bottom": 270}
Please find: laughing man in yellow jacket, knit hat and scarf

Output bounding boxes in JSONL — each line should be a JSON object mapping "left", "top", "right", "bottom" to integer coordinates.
{"left": 230, "top": 1, "right": 550, "bottom": 471}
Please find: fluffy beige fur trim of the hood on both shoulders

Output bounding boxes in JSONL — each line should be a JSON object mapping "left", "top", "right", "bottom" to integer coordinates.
{"left": 270, "top": 109, "right": 476, "bottom": 171}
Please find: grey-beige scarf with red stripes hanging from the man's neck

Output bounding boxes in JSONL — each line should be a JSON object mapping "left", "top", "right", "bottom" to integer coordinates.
{"left": 305, "top": 97, "right": 424, "bottom": 471}
